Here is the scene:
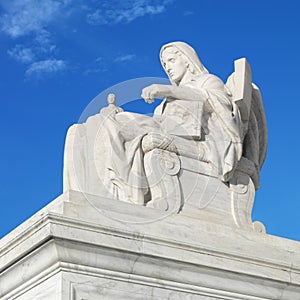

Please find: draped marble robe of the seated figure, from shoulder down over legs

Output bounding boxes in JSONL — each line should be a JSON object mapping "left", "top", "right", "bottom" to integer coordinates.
{"left": 64, "top": 73, "right": 242, "bottom": 204}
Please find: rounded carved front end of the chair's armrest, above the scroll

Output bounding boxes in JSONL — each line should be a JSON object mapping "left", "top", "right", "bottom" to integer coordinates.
{"left": 142, "top": 132, "right": 177, "bottom": 153}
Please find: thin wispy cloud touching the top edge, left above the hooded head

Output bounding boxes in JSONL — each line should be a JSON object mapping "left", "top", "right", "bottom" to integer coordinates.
{"left": 87, "top": 0, "right": 173, "bottom": 25}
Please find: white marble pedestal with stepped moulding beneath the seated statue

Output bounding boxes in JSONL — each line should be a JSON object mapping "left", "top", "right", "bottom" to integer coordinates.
{"left": 0, "top": 191, "right": 300, "bottom": 300}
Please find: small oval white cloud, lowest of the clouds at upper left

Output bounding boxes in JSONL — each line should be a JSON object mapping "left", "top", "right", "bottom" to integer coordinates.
{"left": 25, "top": 59, "right": 66, "bottom": 77}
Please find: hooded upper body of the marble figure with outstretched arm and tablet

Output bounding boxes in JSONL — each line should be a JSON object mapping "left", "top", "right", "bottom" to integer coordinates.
{"left": 142, "top": 42, "right": 242, "bottom": 181}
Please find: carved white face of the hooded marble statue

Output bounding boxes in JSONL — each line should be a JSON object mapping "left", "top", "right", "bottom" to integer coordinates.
{"left": 162, "top": 48, "right": 187, "bottom": 84}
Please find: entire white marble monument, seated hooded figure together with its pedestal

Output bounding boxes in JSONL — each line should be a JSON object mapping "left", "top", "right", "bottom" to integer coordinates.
{"left": 5, "top": 42, "right": 300, "bottom": 300}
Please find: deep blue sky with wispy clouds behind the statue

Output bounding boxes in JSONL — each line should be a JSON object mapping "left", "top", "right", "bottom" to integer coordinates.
{"left": 0, "top": 0, "right": 300, "bottom": 241}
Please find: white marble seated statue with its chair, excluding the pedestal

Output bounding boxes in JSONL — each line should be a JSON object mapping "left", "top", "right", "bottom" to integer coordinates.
{"left": 64, "top": 42, "right": 267, "bottom": 231}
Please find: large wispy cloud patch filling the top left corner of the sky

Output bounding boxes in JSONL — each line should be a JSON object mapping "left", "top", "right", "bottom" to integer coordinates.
{"left": 0, "top": 0, "right": 72, "bottom": 77}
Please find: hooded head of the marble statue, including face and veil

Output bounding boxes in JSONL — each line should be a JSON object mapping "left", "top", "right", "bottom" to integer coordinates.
{"left": 160, "top": 42, "right": 208, "bottom": 85}
